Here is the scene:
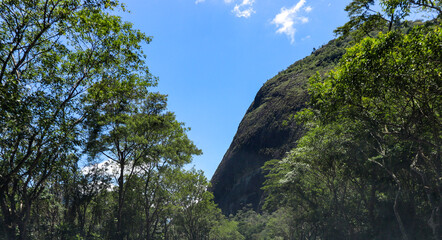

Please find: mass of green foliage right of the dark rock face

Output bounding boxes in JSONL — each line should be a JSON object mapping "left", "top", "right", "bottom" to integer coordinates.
{"left": 264, "top": 24, "right": 442, "bottom": 239}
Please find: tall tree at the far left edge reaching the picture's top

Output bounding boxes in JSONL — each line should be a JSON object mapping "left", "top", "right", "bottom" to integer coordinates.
{"left": 0, "top": 0, "right": 150, "bottom": 239}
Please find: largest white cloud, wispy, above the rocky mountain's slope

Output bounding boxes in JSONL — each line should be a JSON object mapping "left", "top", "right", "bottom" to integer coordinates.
{"left": 272, "top": 0, "right": 313, "bottom": 43}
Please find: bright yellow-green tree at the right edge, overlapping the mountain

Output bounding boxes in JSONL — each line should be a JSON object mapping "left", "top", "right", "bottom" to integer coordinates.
{"left": 310, "top": 24, "right": 442, "bottom": 239}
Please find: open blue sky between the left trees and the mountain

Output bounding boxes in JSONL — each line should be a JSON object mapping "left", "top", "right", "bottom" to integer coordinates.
{"left": 118, "top": 0, "right": 349, "bottom": 179}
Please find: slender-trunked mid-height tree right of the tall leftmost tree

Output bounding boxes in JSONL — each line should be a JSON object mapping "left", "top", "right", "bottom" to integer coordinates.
{"left": 85, "top": 69, "right": 200, "bottom": 239}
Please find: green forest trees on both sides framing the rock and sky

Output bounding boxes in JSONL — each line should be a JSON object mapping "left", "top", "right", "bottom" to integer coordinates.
{"left": 0, "top": 0, "right": 442, "bottom": 240}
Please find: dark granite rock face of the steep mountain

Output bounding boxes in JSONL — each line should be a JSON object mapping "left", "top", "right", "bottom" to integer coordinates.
{"left": 211, "top": 40, "right": 348, "bottom": 215}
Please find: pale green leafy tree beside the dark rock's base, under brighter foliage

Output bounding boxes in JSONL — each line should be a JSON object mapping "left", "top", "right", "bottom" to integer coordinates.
{"left": 263, "top": 120, "right": 382, "bottom": 239}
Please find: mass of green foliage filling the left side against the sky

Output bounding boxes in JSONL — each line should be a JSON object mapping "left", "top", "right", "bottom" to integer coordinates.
{"left": 0, "top": 0, "right": 219, "bottom": 239}
